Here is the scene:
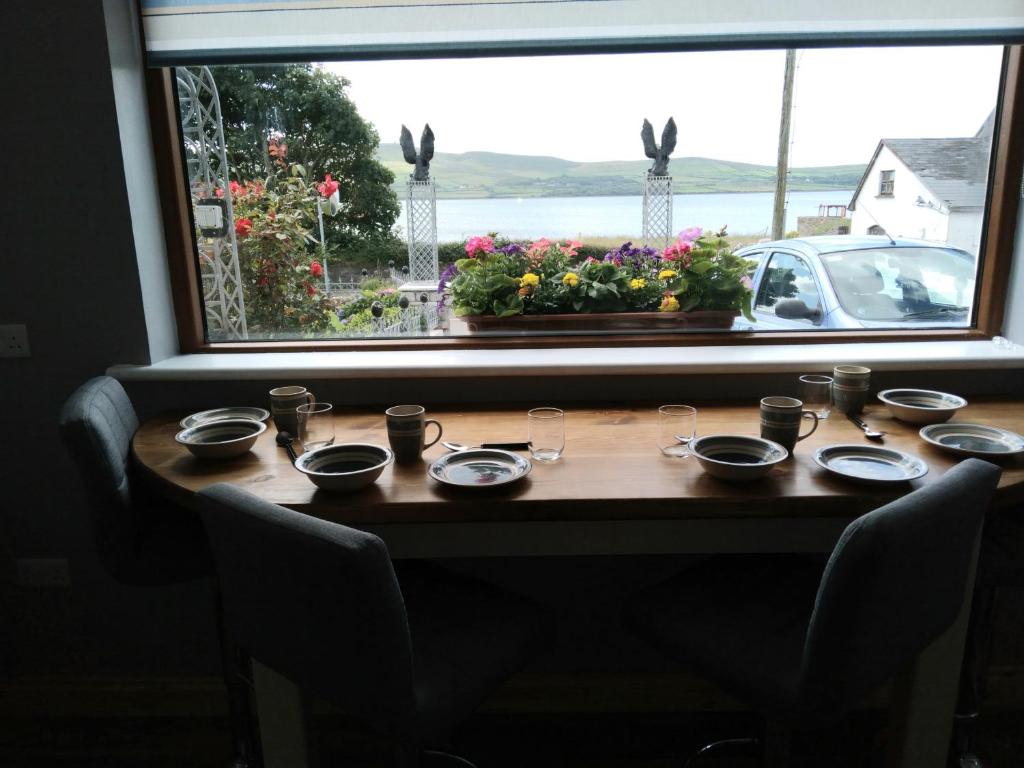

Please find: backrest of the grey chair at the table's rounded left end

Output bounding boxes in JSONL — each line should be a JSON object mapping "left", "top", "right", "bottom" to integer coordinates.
{"left": 59, "top": 376, "right": 138, "bottom": 577}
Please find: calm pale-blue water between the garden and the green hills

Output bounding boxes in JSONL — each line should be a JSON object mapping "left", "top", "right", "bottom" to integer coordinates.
{"left": 398, "top": 190, "right": 853, "bottom": 243}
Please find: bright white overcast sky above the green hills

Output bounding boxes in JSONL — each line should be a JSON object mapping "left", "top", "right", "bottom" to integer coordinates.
{"left": 324, "top": 46, "right": 1002, "bottom": 167}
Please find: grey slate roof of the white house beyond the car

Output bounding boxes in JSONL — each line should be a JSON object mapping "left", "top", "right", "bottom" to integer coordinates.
{"left": 850, "top": 134, "right": 991, "bottom": 210}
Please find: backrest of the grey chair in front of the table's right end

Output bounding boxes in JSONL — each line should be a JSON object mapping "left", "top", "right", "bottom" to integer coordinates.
{"left": 801, "top": 459, "right": 1000, "bottom": 714}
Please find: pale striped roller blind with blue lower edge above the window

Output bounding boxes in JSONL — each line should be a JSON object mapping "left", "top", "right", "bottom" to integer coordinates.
{"left": 139, "top": 0, "right": 1024, "bottom": 67}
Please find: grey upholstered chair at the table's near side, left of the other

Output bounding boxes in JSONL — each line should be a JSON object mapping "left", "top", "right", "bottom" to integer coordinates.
{"left": 199, "top": 483, "right": 550, "bottom": 766}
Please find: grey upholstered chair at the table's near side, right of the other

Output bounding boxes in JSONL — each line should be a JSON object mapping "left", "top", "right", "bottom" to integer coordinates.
{"left": 623, "top": 459, "right": 999, "bottom": 765}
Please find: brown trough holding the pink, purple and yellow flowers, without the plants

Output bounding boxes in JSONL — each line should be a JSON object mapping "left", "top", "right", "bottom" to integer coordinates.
{"left": 453, "top": 310, "right": 739, "bottom": 333}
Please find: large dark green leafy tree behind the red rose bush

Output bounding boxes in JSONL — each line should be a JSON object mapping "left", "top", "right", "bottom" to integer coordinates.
{"left": 214, "top": 65, "right": 400, "bottom": 249}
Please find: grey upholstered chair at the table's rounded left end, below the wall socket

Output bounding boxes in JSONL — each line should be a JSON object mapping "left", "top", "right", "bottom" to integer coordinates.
{"left": 59, "top": 376, "right": 258, "bottom": 765}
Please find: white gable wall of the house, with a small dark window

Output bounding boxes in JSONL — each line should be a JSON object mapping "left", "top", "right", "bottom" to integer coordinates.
{"left": 850, "top": 146, "right": 950, "bottom": 244}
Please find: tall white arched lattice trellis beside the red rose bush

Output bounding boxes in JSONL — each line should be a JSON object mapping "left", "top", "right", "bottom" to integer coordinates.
{"left": 175, "top": 67, "right": 249, "bottom": 341}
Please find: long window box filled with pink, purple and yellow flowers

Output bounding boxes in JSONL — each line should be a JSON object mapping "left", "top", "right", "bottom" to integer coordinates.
{"left": 442, "top": 227, "right": 753, "bottom": 332}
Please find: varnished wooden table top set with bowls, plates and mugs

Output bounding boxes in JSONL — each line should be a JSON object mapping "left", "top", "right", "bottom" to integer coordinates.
{"left": 133, "top": 399, "right": 1024, "bottom": 524}
